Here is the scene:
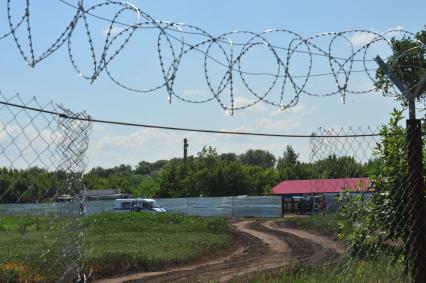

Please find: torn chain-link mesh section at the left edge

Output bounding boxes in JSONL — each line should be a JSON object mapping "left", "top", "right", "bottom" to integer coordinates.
{"left": 0, "top": 93, "right": 91, "bottom": 282}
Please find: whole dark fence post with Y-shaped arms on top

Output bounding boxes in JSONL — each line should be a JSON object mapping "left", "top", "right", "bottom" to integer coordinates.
{"left": 375, "top": 56, "right": 426, "bottom": 283}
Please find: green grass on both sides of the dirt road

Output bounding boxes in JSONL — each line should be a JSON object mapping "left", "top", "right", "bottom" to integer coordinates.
{"left": 0, "top": 213, "right": 409, "bottom": 283}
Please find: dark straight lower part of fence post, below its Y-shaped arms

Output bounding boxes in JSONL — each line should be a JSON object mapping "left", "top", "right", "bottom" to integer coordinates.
{"left": 407, "top": 119, "right": 426, "bottom": 283}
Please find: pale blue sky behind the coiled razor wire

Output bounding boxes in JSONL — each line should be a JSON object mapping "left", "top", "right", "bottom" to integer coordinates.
{"left": 0, "top": 0, "right": 426, "bottom": 167}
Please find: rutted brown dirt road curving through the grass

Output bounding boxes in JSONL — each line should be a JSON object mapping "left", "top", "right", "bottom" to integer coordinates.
{"left": 96, "top": 220, "right": 344, "bottom": 283}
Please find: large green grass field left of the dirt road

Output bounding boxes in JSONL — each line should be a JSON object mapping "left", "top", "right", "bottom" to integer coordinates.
{"left": 0, "top": 213, "right": 230, "bottom": 282}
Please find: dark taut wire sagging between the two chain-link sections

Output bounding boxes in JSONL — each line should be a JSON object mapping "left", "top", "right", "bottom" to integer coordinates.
{"left": 0, "top": 101, "right": 380, "bottom": 138}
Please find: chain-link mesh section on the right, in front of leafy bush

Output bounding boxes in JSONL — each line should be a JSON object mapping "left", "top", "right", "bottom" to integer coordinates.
{"left": 307, "top": 122, "right": 426, "bottom": 282}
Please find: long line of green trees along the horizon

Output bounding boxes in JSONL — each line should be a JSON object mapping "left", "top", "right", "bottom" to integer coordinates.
{"left": 0, "top": 145, "right": 372, "bottom": 203}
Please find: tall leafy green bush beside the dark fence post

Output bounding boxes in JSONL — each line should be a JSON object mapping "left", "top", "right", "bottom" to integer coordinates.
{"left": 341, "top": 110, "right": 426, "bottom": 268}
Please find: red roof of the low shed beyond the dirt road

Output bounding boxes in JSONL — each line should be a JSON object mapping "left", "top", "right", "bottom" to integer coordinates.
{"left": 272, "top": 178, "right": 368, "bottom": 195}
